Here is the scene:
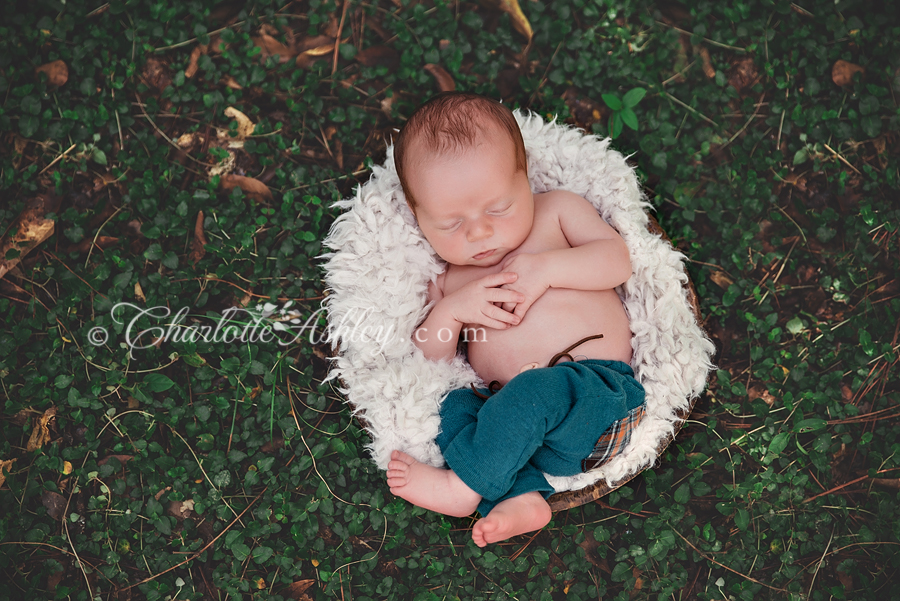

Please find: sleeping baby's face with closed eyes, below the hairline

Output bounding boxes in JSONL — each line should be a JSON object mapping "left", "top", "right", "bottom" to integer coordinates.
{"left": 408, "top": 134, "right": 534, "bottom": 267}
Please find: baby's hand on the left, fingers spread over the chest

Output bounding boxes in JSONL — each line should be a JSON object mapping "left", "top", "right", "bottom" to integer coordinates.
{"left": 444, "top": 272, "right": 525, "bottom": 330}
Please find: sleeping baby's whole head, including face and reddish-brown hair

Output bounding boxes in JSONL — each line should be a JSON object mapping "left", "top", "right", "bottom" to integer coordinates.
{"left": 394, "top": 92, "right": 534, "bottom": 267}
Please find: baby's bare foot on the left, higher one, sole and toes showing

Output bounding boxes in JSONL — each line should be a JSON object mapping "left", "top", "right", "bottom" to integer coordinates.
{"left": 387, "top": 451, "right": 481, "bottom": 517}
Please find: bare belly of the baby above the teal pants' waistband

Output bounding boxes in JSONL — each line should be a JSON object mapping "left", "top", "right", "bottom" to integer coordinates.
{"left": 463, "top": 288, "right": 631, "bottom": 384}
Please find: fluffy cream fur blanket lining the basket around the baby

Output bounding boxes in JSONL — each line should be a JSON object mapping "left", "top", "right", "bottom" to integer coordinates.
{"left": 322, "top": 110, "right": 714, "bottom": 492}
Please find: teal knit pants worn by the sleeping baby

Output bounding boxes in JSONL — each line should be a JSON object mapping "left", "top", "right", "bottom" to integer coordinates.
{"left": 436, "top": 359, "right": 644, "bottom": 516}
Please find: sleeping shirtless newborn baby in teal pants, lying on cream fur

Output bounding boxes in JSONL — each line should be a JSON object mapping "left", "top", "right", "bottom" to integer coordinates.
{"left": 387, "top": 92, "right": 644, "bottom": 547}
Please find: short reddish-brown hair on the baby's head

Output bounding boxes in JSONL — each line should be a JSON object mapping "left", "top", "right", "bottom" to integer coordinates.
{"left": 394, "top": 92, "right": 528, "bottom": 212}
